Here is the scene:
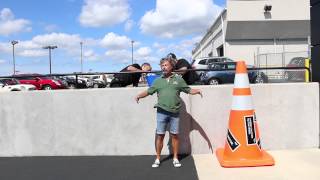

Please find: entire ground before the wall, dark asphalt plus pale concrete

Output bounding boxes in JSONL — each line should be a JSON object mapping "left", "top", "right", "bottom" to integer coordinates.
{"left": 0, "top": 148, "right": 320, "bottom": 180}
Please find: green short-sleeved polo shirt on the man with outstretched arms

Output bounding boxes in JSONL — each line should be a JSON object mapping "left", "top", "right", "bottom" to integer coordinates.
{"left": 148, "top": 74, "right": 191, "bottom": 113}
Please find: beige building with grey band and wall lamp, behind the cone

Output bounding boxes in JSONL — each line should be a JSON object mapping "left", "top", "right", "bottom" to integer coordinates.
{"left": 192, "top": 0, "right": 310, "bottom": 64}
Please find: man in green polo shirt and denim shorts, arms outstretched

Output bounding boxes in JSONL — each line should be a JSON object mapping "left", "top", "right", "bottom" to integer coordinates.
{"left": 135, "top": 58, "right": 202, "bottom": 167}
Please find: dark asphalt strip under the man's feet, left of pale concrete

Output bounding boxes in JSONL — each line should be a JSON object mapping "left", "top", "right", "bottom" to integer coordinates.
{"left": 0, "top": 156, "right": 198, "bottom": 180}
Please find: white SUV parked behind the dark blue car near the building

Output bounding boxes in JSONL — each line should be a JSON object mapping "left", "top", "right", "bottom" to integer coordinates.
{"left": 191, "top": 57, "right": 234, "bottom": 74}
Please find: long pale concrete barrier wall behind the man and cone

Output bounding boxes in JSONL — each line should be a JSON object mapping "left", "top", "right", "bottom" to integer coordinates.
{"left": 0, "top": 83, "right": 319, "bottom": 156}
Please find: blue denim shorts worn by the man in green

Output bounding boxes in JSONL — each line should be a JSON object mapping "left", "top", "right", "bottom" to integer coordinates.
{"left": 156, "top": 108, "right": 179, "bottom": 134}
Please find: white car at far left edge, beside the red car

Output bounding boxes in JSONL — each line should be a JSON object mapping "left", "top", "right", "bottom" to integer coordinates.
{"left": 0, "top": 78, "right": 36, "bottom": 92}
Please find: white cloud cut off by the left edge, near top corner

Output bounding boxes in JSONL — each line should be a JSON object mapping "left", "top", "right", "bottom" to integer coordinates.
{"left": 0, "top": 8, "right": 32, "bottom": 36}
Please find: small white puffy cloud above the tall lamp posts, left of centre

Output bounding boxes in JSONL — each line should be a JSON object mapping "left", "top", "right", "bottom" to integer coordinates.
{"left": 101, "top": 32, "right": 131, "bottom": 50}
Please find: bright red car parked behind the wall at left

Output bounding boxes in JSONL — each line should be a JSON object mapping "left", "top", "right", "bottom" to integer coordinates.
{"left": 14, "top": 74, "right": 66, "bottom": 90}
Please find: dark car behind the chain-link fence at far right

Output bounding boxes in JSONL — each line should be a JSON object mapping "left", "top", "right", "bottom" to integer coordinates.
{"left": 284, "top": 57, "right": 307, "bottom": 81}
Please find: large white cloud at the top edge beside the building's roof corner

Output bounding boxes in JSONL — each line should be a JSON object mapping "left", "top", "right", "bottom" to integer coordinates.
{"left": 140, "top": 0, "right": 222, "bottom": 38}
